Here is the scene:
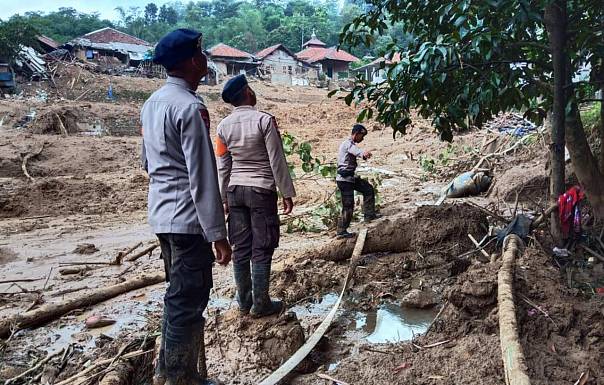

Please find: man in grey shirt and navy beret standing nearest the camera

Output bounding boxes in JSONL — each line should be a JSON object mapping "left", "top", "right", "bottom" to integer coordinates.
{"left": 141, "top": 29, "right": 231, "bottom": 385}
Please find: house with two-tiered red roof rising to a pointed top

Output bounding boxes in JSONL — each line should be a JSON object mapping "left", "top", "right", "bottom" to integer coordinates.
{"left": 296, "top": 32, "right": 359, "bottom": 80}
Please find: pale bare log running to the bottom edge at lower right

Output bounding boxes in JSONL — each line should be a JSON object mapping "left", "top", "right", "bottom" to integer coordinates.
{"left": 497, "top": 235, "right": 531, "bottom": 385}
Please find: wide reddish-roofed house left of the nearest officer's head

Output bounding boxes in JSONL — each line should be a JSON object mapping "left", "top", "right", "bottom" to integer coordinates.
{"left": 65, "top": 27, "right": 153, "bottom": 66}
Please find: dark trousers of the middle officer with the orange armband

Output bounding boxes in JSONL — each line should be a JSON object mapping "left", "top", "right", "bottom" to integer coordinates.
{"left": 227, "top": 186, "right": 279, "bottom": 264}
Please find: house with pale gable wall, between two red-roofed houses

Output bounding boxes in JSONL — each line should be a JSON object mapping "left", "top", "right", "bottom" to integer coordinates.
{"left": 254, "top": 44, "right": 318, "bottom": 85}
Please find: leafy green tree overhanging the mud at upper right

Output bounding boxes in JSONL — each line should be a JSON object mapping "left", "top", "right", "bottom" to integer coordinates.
{"left": 340, "top": 0, "right": 604, "bottom": 232}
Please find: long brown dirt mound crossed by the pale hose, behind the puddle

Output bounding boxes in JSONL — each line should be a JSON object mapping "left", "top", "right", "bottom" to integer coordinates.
{"left": 304, "top": 203, "right": 488, "bottom": 261}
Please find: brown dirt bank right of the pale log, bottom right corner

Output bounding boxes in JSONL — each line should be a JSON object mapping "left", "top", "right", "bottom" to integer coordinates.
{"left": 515, "top": 248, "right": 604, "bottom": 385}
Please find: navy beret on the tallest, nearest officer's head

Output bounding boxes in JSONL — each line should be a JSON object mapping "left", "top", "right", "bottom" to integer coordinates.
{"left": 153, "top": 28, "right": 201, "bottom": 69}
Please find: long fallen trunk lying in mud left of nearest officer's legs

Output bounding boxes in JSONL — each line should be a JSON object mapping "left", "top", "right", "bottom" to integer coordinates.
{"left": 0, "top": 273, "right": 165, "bottom": 338}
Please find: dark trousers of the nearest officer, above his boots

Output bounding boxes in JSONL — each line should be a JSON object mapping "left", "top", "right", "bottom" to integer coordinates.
{"left": 157, "top": 234, "right": 214, "bottom": 327}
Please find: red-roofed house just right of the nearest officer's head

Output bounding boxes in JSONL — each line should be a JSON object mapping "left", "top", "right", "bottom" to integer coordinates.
{"left": 208, "top": 43, "right": 260, "bottom": 81}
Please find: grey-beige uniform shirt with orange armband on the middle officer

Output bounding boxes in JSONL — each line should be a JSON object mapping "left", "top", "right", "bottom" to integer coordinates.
{"left": 216, "top": 106, "right": 296, "bottom": 202}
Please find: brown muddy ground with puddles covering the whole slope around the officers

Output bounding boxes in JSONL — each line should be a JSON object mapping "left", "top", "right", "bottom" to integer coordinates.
{"left": 0, "top": 66, "right": 604, "bottom": 385}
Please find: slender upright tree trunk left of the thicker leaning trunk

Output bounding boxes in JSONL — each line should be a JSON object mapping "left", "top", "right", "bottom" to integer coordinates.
{"left": 545, "top": 0, "right": 568, "bottom": 246}
